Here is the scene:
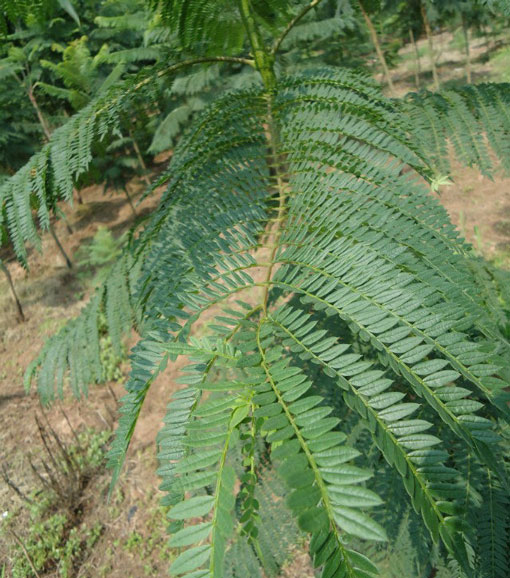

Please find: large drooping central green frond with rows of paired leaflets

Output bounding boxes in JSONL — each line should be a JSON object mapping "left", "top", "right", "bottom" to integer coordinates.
{"left": 89, "top": 66, "right": 506, "bottom": 576}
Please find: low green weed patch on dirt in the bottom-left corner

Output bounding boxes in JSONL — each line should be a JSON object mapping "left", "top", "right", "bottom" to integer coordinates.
{"left": 0, "top": 420, "right": 111, "bottom": 578}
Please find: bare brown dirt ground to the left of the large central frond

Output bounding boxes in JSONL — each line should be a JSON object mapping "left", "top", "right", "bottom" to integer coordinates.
{"left": 0, "top": 179, "right": 173, "bottom": 578}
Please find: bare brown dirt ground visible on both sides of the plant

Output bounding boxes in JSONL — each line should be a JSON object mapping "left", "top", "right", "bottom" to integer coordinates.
{"left": 0, "top": 30, "right": 510, "bottom": 578}
